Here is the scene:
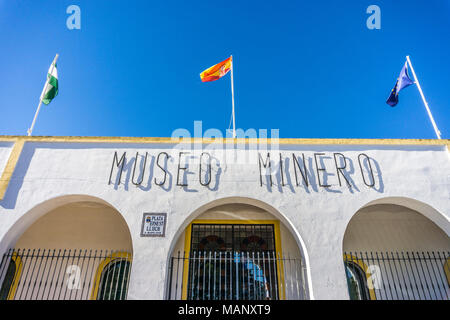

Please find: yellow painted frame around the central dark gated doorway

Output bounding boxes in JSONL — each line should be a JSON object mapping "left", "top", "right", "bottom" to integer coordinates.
{"left": 181, "top": 219, "right": 286, "bottom": 300}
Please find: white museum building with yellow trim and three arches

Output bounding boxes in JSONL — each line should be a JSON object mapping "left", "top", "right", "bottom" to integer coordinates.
{"left": 0, "top": 136, "right": 450, "bottom": 300}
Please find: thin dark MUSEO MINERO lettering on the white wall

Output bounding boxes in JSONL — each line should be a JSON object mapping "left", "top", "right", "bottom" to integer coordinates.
{"left": 108, "top": 151, "right": 383, "bottom": 192}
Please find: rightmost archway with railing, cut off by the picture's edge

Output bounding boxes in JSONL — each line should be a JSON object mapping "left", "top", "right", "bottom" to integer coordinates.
{"left": 343, "top": 197, "right": 450, "bottom": 300}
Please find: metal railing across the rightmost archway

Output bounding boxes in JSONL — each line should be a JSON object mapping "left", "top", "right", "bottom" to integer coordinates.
{"left": 344, "top": 251, "right": 450, "bottom": 300}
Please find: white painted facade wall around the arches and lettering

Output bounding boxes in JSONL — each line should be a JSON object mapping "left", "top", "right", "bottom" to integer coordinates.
{"left": 0, "top": 142, "right": 450, "bottom": 299}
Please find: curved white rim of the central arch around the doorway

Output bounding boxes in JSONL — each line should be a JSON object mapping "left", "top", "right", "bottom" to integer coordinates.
{"left": 164, "top": 197, "right": 314, "bottom": 299}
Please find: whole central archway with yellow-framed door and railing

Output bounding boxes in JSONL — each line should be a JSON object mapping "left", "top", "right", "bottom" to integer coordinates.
{"left": 166, "top": 197, "right": 310, "bottom": 300}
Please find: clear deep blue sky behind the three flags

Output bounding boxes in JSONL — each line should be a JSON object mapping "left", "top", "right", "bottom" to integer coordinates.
{"left": 0, "top": 0, "right": 450, "bottom": 138}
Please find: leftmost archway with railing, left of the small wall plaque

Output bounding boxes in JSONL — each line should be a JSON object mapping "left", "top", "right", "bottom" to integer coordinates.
{"left": 0, "top": 195, "right": 133, "bottom": 300}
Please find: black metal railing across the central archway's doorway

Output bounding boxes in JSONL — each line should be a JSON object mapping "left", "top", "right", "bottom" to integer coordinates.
{"left": 166, "top": 251, "right": 306, "bottom": 300}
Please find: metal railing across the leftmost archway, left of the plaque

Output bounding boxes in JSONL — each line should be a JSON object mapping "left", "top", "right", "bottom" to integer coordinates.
{"left": 0, "top": 249, "right": 132, "bottom": 300}
